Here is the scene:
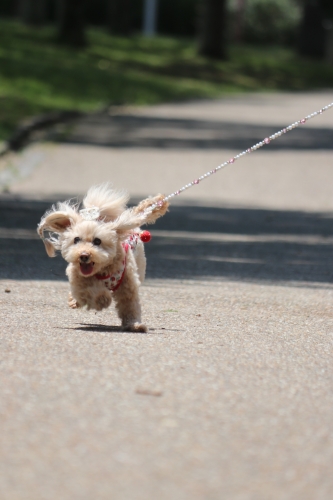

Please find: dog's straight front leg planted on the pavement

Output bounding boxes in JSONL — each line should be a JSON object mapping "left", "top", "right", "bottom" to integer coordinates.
{"left": 114, "top": 258, "right": 147, "bottom": 333}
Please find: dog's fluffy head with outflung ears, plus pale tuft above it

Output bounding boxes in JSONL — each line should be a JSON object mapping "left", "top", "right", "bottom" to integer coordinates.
{"left": 37, "top": 184, "right": 167, "bottom": 277}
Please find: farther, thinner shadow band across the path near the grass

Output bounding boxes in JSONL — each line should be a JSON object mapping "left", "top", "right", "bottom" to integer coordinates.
{"left": 57, "top": 113, "right": 333, "bottom": 151}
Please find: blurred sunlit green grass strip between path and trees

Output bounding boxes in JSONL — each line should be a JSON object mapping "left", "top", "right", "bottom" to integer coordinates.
{"left": 0, "top": 20, "right": 333, "bottom": 139}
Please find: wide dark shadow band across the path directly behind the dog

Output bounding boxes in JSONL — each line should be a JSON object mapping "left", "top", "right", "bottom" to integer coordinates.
{"left": 0, "top": 197, "right": 333, "bottom": 285}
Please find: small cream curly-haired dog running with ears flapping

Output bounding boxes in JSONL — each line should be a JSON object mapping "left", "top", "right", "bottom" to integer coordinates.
{"left": 38, "top": 184, "right": 168, "bottom": 332}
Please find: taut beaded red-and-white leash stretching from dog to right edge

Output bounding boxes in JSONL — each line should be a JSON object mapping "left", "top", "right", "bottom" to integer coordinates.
{"left": 144, "top": 102, "right": 333, "bottom": 213}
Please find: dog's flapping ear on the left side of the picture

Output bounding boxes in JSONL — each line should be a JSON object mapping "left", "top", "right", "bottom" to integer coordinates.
{"left": 37, "top": 207, "right": 79, "bottom": 257}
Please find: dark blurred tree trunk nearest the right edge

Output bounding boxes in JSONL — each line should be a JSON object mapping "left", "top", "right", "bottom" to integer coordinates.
{"left": 298, "top": 0, "right": 326, "bottom": 59}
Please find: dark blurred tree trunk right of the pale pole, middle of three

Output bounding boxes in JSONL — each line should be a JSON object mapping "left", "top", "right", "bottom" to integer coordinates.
{"left": 199, "top": 0, "right": 227, "bottom": 59}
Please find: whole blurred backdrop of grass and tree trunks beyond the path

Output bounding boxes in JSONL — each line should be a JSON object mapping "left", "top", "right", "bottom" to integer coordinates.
{"left": 0, "top": 0, "right": 333, "bottom": 145}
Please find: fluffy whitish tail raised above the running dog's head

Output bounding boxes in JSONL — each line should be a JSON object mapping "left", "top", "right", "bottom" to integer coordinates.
{"left": 83, "top": 183, "right": 129, "bottom": 222}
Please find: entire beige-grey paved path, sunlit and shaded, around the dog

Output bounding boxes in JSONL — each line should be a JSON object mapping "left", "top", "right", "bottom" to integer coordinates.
{"left": 0, "top": 91, "right": 333, "bottom": 500}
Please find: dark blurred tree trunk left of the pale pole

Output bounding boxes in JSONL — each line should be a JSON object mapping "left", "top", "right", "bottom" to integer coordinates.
{"left": 58, "top": 0, "right": 86, "bottom": 47}
